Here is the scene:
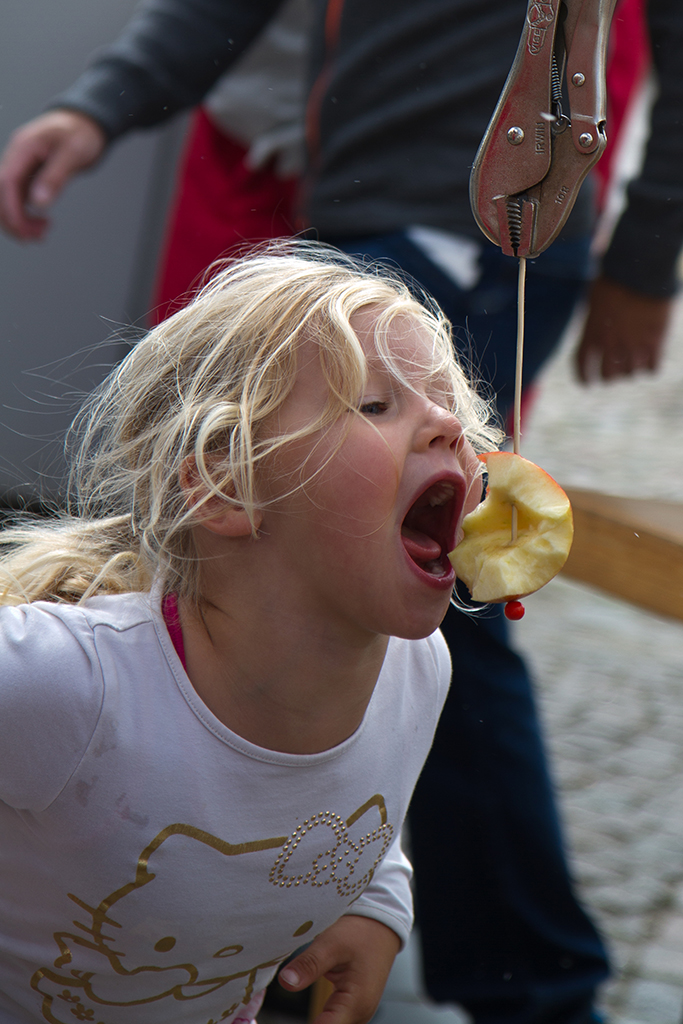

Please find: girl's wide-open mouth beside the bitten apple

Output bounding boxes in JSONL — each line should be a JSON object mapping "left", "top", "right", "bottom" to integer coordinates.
{"left": 400, "top": 480, "right": 458, "bottom": 577}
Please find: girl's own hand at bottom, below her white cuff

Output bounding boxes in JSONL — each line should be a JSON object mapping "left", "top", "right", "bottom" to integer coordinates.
{"left": 280, "top": 914, "right": 400, "bottom": 1024}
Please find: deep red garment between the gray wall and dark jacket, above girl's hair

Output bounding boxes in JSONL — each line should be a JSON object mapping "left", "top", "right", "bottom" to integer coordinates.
{"left": 152, "top": 108, "right": 296, "bottom": 324}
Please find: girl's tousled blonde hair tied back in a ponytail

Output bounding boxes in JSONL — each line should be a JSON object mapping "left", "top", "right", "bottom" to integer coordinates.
{"left": 0, "top": 242, "right": 502, "bottom": 604}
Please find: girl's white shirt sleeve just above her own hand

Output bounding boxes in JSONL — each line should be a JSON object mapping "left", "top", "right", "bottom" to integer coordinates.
{"left": 346, "top": 839, "right": 413, "bottom": 948}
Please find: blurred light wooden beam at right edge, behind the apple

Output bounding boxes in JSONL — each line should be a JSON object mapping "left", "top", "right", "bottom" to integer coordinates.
{"left": 562, "top": 487, "right": 683, "bottom": 620}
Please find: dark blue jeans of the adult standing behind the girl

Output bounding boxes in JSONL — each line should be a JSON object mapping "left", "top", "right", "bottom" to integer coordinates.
{"left": 329, "top": 232, "right": 608, "bottom": 1024}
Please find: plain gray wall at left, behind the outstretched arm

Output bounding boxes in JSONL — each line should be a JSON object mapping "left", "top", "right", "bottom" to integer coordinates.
{"left": 0, "top": 0, "right": 183, "bottom": 501}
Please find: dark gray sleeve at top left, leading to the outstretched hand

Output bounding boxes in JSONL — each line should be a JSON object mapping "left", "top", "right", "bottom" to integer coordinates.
{"left": 49, "top": 0, "right": 282, "bottom": 139}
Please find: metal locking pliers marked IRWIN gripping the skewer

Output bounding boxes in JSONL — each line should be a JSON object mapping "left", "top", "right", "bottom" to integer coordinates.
{"left": 470, "top": 0, "right": 615, "bottom": 258}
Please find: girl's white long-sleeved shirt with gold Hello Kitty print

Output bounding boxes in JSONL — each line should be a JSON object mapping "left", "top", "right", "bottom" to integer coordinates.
{"left": 0, "top": 594, "right": 451, "bottom": 1024}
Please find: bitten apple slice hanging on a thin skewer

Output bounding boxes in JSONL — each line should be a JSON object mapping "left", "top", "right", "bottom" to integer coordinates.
{"left": 449, "top": 452, "right": 573, "bottom": 603}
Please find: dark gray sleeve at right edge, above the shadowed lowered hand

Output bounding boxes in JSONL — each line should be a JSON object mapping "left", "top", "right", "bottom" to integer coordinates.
{"left": 602, "top": 0, "right": 683, "bottom": 297}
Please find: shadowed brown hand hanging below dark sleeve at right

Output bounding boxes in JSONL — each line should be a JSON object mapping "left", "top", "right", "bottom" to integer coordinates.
{"left": 575, "top": 278, "right": 673, "bottom": 384}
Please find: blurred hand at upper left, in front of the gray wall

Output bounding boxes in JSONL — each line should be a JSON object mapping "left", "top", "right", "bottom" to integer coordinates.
{"left": 0, "top": 110, "right": 106, "bottom": 240}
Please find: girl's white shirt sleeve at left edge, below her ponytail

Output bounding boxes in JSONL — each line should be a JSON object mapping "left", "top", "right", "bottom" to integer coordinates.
{"left": 0, "top": 603, "right": 102, "bottom": 811}
